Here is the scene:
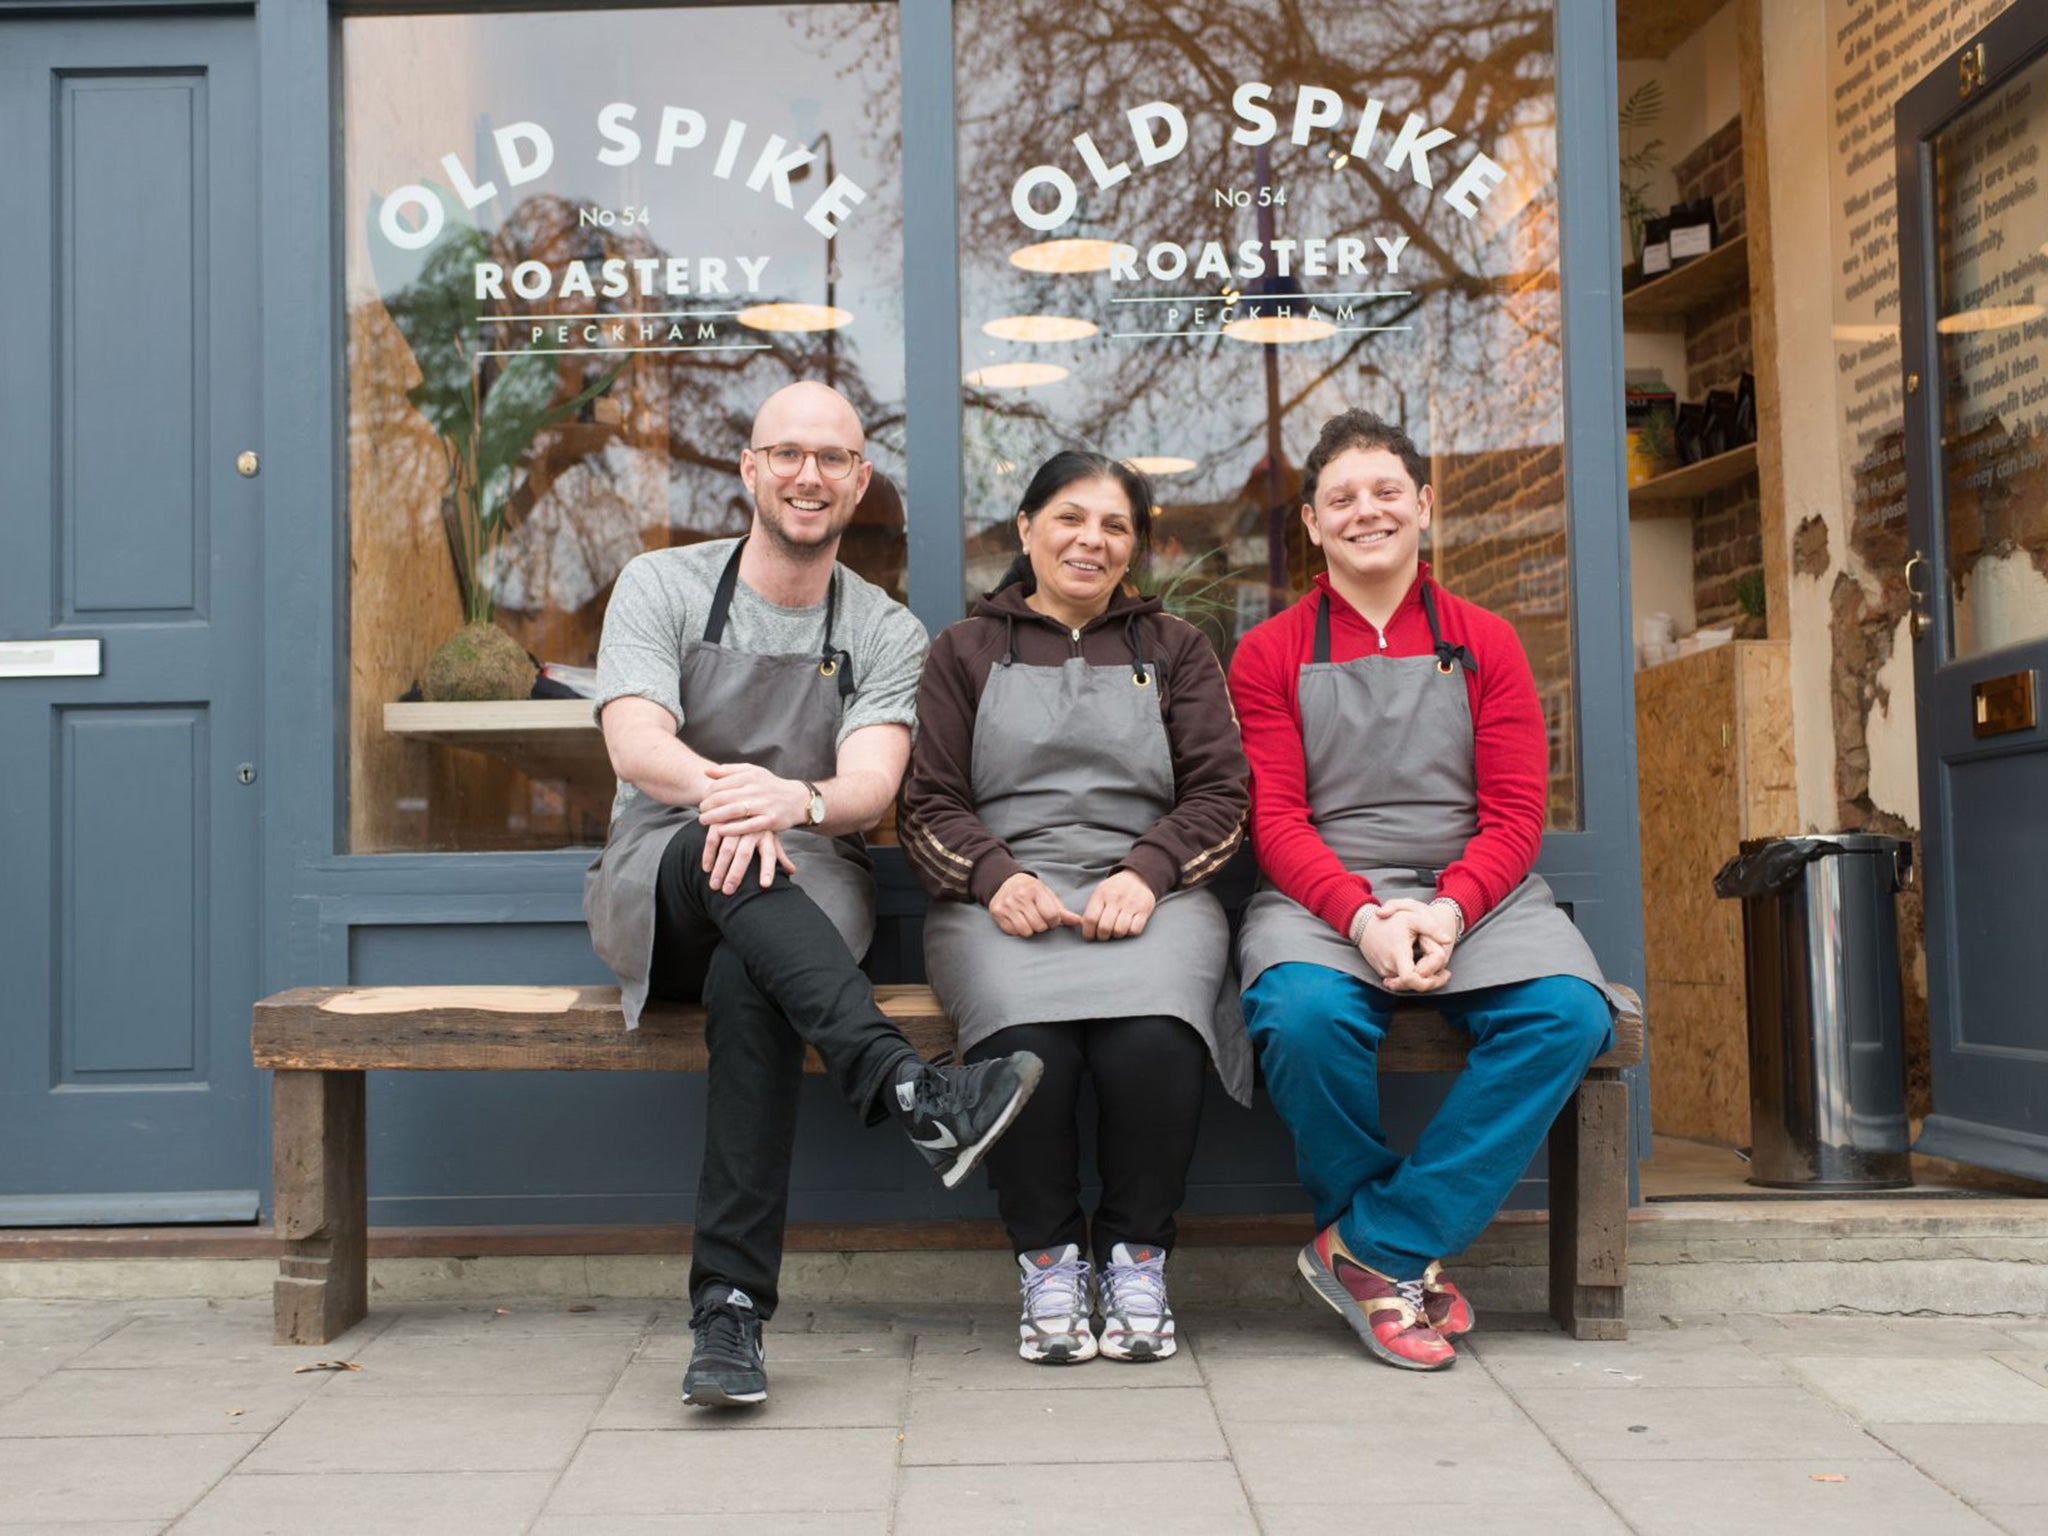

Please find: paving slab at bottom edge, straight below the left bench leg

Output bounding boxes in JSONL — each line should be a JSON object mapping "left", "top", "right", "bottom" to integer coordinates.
{"left": 165, "top": 1473, "right": 555, "bottom": 1536}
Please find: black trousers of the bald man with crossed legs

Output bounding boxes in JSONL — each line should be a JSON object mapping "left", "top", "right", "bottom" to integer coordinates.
{"left": 649, "top": 821, "right": 915, "bottom": 1317}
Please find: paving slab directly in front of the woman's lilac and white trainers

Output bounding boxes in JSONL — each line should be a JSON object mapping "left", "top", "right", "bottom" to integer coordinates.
{"left": 903, "top": 1366, "right": 1227, "bottom": 1470}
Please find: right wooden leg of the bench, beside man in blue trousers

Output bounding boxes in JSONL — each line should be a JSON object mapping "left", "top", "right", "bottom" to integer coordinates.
{"left": 1550, "top": 1071, "right": 1628, "bottom": 1339}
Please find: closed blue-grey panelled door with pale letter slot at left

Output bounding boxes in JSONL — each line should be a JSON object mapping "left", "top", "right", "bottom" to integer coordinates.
{"left": 0, "top": 16, "right": 266, "bottom": 1225}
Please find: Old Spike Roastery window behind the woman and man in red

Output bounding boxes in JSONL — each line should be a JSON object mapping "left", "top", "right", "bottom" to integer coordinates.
{"left": 954, "top": 0, "right": 1579, "bottom": 827}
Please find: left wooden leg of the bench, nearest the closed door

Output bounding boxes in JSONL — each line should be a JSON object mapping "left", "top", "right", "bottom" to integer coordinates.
{"left": 270, "top": 1071, "right": 371, "bottom": 1343}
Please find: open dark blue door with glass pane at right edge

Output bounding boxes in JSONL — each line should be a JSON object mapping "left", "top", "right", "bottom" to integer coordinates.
{"left": 1898, "top": 6, "right": 2048, "bottom": 1178}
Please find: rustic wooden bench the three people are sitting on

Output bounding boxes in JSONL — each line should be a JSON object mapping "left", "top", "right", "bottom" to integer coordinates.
{"left": 252, "top": 987, "right": 1642, "bottom": 1343}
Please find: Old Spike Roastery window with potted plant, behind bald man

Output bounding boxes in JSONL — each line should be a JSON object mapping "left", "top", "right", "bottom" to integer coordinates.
{"left": 340, "top": 4, "right": 905, "bottom": 852}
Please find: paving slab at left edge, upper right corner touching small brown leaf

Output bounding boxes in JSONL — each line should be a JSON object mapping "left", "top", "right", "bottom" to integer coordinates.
{"left": 0, "top": 1362, "right": 322, "bottom": 1441}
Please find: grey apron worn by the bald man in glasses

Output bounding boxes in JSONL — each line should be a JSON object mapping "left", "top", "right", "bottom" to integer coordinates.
{"left": 584, "top": 539, "right": 874, "bottom": 1028}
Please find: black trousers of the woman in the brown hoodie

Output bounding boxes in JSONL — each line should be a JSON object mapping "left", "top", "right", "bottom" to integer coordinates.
{"left": 967, "top": 1016, "right": 1208, "bottom": 1264}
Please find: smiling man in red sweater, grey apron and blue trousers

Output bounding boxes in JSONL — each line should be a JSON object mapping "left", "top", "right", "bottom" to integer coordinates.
{"left": 1231, "top": 412, "right": 1612, "bottom": 1370}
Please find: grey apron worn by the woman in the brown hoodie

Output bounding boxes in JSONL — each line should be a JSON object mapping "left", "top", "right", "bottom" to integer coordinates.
{"left": 924, "top": 629, "right": 1251, "bottom": 1104}
